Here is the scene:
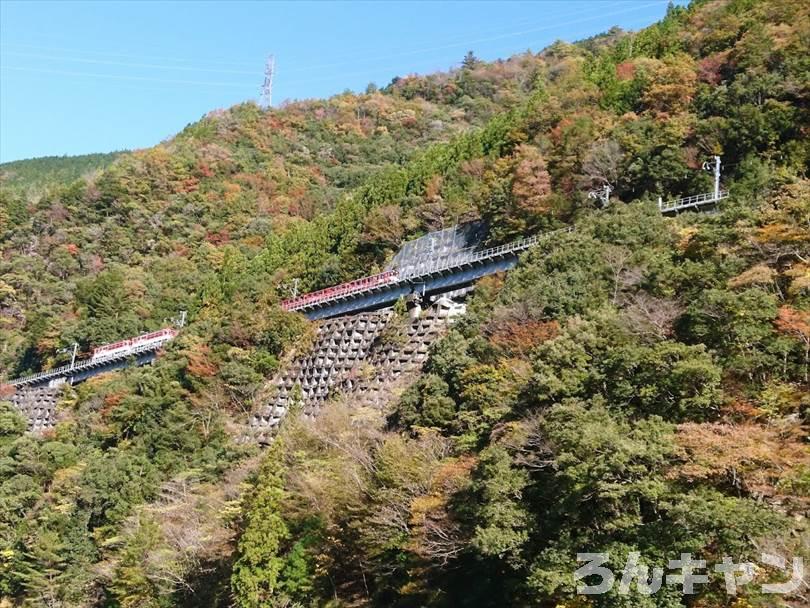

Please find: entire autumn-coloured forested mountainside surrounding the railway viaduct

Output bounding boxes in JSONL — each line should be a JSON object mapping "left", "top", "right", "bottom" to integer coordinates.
{"left": 0, "top": 0, "right": 810, "bottom": 608}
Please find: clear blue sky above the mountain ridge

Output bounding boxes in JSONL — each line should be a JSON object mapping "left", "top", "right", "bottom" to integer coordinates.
{"left": 0, "top": 0, "right": 683, "bottom": 162}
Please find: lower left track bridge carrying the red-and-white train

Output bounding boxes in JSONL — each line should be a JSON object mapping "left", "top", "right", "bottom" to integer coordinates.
{"left": 7, "top": 336, "right": 173, "bottom": 388}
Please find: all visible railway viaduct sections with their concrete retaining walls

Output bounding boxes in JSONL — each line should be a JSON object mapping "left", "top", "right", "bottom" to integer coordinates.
{"left": 7, "top": 190, "right": 728, "bottom": 432}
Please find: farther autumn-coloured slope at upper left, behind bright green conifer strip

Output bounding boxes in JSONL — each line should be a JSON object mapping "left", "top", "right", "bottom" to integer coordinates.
{"left": 0, "top": 48, "right": 539, "bottom": 373}
